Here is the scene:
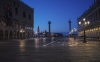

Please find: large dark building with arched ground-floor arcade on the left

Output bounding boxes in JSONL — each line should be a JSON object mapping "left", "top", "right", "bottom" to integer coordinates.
{"left": 0, "top": 0, "right": 34, "bottom": 39}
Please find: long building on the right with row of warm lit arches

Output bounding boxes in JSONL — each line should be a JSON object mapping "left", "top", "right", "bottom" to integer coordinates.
{"left": 77, "top": 0, "right": 100, "bottom": 38}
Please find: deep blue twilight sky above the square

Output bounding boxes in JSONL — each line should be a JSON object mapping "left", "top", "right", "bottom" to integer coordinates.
{"left": 22, "top": 0, "right": 94, "bottom": 32}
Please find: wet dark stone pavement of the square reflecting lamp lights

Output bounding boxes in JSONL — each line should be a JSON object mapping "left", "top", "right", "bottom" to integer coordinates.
{"left": 0, "top": 38, "right": 100, "bottom": 62}
